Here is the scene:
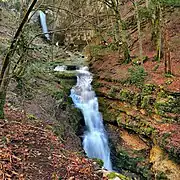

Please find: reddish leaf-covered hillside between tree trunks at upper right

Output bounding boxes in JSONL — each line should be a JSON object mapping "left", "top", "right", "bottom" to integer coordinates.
{"left": 91, "top": 8, "right": 180, "bottom": 92}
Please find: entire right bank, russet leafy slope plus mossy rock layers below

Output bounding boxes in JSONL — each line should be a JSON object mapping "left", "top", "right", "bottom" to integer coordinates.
{"left": 88, "top": 2, "right": 180, "bottom": 180}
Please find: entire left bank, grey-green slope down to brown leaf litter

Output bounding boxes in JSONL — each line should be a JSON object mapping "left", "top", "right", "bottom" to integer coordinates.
{"left": 0, "top": 6, "right": 102, "bottom": 180}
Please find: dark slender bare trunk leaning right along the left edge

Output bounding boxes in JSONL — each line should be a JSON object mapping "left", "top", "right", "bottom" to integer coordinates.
{"left": 0, "top": 0, "right": 37, "bottom": 118}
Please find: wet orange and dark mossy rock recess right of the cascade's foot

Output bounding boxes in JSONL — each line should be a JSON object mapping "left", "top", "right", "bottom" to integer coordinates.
{"left": 107, "top": 125, "right": 153, "bottom": 179}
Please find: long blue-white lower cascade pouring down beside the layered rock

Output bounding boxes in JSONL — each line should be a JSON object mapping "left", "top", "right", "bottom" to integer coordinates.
{"left": 70, "top": 67, "right": 112, "bottom": 170}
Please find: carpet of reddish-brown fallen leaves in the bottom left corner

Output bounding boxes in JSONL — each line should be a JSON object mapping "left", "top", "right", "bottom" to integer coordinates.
{"left": 0, "top": 107, "right": 105, "bottom": 180}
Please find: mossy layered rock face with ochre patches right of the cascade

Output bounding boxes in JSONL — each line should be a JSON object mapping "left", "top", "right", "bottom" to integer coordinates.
{"left": 91, "top": 60, "right": 180, "bottom": 180}
